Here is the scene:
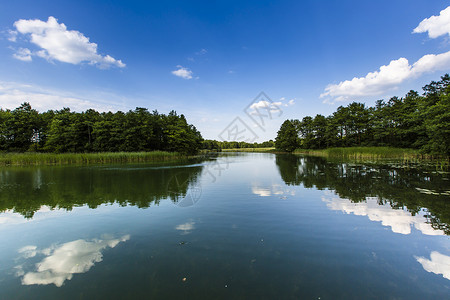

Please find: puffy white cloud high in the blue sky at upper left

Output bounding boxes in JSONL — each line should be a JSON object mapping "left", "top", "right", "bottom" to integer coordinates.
{"left": 14, "top": 17, "right": 125, "bottom": 68}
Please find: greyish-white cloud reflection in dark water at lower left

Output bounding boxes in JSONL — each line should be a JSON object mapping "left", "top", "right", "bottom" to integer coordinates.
{"left": 16, "top": 235, "right": 130, "bottom": 287}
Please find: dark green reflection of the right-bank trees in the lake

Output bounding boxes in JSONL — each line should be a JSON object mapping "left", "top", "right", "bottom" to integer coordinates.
{"left": 275, "top": 154, "right": 450, "bottom": 235}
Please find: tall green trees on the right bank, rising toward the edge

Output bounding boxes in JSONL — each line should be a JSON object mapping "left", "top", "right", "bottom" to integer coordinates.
{"left": 275, "top": 74, "right": 450, "bottom": 156}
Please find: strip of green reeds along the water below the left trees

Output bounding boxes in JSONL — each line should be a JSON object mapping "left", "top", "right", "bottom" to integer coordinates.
{"left": 0, "top": 151, "right": 186, "bottom": 166}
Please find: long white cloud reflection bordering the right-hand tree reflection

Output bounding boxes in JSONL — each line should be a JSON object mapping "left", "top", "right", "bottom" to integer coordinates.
{"left": 322, "top": 194, "right": 444, "bottom": 235}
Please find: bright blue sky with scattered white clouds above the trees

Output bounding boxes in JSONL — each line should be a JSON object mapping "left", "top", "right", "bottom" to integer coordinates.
{"left": 0, "top": 0, "right": 450, "bottom": 142}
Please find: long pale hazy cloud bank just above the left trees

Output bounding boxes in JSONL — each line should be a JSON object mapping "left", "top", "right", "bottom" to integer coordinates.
{"left": 0, "top": 81, "right": 126, "bottom": 112}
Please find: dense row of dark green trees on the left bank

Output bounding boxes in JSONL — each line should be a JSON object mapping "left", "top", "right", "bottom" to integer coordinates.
{"left": 0, "top": 102, "right": 203, "bottom": 154}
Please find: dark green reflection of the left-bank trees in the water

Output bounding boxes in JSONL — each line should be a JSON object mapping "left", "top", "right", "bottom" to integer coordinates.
{"left": 0, "top": 164, "right": 203, "bottom": 218}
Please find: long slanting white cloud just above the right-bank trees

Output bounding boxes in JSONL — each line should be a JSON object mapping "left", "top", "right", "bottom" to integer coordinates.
{"left": 320, "top": 51, "right": 450, "bottom": 102}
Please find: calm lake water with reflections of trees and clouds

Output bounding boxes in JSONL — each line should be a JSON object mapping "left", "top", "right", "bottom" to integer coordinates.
{"left": 0, "top": 154, "right": 450, "bottom": 299}
